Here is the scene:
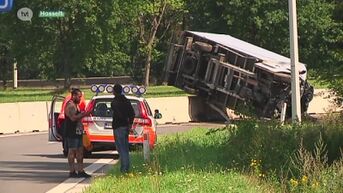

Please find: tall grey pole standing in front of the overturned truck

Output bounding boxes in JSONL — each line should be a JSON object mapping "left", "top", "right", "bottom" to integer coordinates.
{"left": 288, "top": 0, "right": 301, "bottom": 123}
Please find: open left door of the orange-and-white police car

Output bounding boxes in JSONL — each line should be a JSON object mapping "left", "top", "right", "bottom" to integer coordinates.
{"left": 48, "top": 95, "right": 65, "bottom": 141}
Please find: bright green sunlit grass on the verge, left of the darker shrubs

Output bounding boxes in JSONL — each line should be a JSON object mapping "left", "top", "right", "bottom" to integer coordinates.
{"left": 86, "top": 128, "right": 278, "bottom": 193}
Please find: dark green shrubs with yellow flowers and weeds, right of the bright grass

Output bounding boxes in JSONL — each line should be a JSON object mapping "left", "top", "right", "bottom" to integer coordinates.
{"left": 225, "top": 118, "right": 343, "bottom": 192}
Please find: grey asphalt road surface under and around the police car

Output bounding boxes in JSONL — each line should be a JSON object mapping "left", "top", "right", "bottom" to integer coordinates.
{"left": 0, "top": 123, "right": 226, "bottom": 193}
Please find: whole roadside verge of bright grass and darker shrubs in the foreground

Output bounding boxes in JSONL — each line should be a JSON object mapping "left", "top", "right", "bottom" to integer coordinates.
{"left": 86, "top": 114, "right": 343, "bottom": 193}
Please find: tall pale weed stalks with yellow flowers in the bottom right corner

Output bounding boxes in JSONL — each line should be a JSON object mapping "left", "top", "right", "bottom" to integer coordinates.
{"left": 289, "top": 136, "right": 343, "bottom": 193}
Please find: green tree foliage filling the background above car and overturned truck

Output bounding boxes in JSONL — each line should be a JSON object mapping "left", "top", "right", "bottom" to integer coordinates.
{"left": 0, "top": 0, "right": 343, "bottom": 96}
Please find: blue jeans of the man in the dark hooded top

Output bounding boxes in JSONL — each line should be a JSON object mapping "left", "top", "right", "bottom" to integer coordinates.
{"left": 113, "top": 127, "right": 130, "bottom": 173}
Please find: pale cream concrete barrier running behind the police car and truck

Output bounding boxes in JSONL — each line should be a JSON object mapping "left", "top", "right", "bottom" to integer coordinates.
{"left": 0, "top": 90, "right": 342, "bottom": 133}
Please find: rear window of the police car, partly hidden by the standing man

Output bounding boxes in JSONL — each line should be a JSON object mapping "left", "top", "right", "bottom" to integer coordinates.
{"left": 92, "top": 99, "right": 141, "bottom": 117}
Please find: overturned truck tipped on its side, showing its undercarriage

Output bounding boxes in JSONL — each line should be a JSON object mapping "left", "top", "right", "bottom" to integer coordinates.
{"left": 166, "top": 31, "right": 313, "bottom": 120}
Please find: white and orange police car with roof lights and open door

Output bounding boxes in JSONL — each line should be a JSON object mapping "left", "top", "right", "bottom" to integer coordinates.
{"left": 49, "top": 84, "right": 161, "bottom": 155}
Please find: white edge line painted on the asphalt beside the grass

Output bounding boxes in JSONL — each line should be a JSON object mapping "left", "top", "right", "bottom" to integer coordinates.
{"left": 46, "top": 156, "right": 118, "bottom": 193}
